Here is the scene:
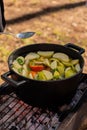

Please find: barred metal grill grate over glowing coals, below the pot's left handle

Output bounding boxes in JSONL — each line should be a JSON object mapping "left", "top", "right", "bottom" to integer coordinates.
{"left": 0, "top": 93, "right": 60, "bottom": 130}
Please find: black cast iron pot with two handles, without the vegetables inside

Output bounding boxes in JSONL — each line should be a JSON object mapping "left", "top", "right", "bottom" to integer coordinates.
{"left": 1, "top": 43, "right": 85, "bottom": 105}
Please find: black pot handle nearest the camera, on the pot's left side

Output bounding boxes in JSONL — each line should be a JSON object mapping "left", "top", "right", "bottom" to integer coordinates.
{"left": 1, "top": 71, "right": 26, "bottom": 88}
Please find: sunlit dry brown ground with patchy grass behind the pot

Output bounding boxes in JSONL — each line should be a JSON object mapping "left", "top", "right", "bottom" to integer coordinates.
{"left": 0, "top": 0, "right": 87, "bottom": 83}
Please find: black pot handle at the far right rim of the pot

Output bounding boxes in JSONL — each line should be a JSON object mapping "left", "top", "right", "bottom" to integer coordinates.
{"left": 64, "top": 43, "right": 85, "bottom": 54}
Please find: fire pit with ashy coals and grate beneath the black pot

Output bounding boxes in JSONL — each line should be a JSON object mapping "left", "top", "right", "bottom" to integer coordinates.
{"left": 0, "top": 74, "right": 87, "bottom": 130}
